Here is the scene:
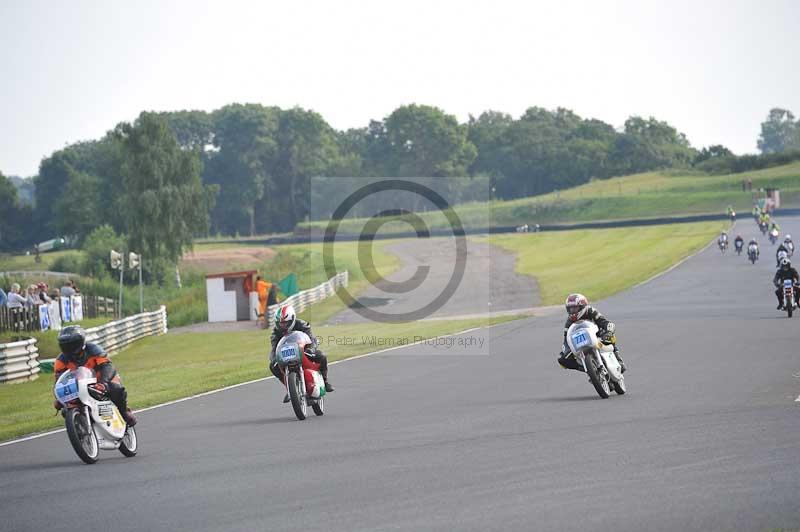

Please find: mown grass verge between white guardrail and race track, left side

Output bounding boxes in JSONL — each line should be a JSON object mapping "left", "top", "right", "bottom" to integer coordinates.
{"left": 0, "top": 318, "right": 512, "bottom": 444}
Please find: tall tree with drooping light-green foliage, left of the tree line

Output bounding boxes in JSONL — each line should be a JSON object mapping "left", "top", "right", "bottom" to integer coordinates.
{"left": 115, "top": 112, "right": 213, "bottom": 265}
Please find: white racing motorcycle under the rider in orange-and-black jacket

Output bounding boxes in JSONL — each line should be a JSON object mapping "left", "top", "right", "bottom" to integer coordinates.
{"left": 53, "top": 366, "right": 138, "bottom": 464}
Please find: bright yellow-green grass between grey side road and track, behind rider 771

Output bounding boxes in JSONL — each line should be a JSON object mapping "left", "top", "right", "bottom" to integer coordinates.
{"left": 488, "top": 222, "right": 728, "bottom": 305}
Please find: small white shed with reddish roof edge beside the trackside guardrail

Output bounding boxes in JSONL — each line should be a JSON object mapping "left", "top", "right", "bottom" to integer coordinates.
{"left": 206, "top": 270, "right": 258, "bottom": 322}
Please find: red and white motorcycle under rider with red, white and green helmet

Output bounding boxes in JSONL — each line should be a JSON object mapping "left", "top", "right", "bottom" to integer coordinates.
{"left": 275, "top": 331, "right": 325, "bottom": 421}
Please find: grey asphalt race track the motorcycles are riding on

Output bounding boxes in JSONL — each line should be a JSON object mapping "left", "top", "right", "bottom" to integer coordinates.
{"left": 0, "top": 219, "right": 800, "bottom": 532}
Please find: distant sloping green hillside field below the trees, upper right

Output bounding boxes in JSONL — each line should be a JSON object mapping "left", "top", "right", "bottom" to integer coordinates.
{"left": 301, "top": 163, "right": 800, "bottom": 233}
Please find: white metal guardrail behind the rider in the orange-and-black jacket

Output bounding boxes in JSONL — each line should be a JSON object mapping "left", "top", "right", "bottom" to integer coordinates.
{"left": 0, "top": 306, "right": 167, "bottom": 383}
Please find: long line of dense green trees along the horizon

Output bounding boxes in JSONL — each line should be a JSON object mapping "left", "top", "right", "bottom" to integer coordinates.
{"left": 0, "top": 104, "right": 800, "bottom": 263}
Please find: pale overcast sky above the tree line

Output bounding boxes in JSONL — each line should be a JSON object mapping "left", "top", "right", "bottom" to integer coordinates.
{"left": 0, "top": 0, "right": 800, "bottom": 176}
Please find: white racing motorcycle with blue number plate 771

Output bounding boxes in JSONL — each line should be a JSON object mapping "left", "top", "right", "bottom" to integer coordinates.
{"left": 567, "top": 320, "right": 626, "bottom": 399}
